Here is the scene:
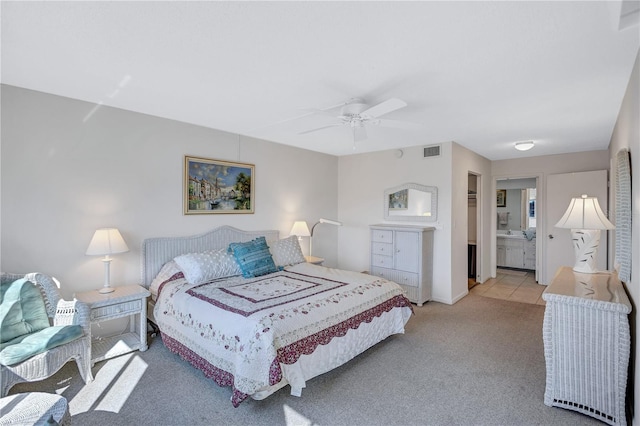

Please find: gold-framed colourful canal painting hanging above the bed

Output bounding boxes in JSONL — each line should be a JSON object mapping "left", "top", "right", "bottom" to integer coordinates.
{"left": 183, "top": 156, "right": 255, "bottom": 214}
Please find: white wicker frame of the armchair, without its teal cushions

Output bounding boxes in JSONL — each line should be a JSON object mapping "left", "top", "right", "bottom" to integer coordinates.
{"left": 0, "top": 273, "right": 93, "bottom": 397}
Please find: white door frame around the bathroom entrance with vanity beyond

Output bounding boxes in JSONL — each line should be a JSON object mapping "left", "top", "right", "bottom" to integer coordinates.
{"left": 491, "top": 173, "right": 547, "bottom": 284}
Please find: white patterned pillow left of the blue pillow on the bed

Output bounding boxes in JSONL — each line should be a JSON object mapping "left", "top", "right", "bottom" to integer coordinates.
{"left": 173, "top": 249, "right": 242, "bottom": 284}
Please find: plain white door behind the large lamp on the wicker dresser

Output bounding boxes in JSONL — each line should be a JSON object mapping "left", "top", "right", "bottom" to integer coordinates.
{"left": 537, "top": 170, "right": 609, "bottom": 284}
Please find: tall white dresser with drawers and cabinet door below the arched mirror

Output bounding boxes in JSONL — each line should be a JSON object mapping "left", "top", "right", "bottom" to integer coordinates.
{"left": 370, "top": 225, "right": 435, "bottom": 306}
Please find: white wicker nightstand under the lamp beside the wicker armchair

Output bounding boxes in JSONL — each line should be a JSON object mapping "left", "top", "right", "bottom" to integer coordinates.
{"left": 75, "top": 285, "right": 151, "bottom": 364}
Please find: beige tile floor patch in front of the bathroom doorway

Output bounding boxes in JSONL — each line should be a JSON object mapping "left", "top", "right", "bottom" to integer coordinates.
{"left": 469, "top": 269, "right": 547, "bottom": 305}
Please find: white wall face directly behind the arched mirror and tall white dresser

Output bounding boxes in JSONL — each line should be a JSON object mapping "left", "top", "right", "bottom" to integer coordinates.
{"left": 338, "top": 142, "right": 452, "bottom": 303}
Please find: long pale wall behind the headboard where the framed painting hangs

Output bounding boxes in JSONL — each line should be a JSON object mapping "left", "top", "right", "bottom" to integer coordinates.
{"left": 0, "top": 85, "right": 338, "bottom": 297}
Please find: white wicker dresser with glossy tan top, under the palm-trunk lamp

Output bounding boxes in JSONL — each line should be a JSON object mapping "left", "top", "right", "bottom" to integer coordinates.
{"left": 542, "top": 266, "right": 631, "bottom": 425}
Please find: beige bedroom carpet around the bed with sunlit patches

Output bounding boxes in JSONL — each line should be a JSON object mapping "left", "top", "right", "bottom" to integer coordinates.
{"left": 11, "top": 294, "right": 601, "bottom": 426}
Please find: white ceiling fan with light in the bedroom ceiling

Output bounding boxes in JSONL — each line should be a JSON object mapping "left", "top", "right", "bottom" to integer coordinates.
{"left": 298, "top": 98, "right": 419, "bottom": 142}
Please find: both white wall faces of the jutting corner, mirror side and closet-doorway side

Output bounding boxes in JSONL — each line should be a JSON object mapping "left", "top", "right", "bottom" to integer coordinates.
{"left": 338, "top": 142, "right": 495, "bottom": 304}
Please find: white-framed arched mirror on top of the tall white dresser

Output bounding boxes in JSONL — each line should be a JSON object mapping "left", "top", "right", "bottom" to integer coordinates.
{"left": 384, "top": 183, "right": 438, "bottom": 222}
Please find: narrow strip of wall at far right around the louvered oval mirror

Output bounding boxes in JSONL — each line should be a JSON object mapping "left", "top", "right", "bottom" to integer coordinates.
{"left": 609, "top": 47, "right": 640, "bottom": 424}
